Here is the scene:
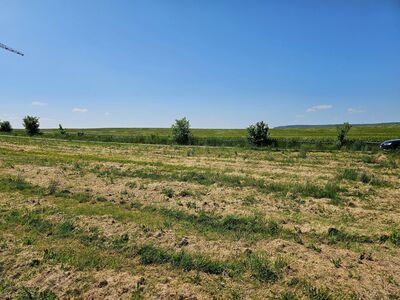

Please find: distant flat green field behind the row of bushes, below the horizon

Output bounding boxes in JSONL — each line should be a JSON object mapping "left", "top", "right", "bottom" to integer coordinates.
{"left": 10, "top": 124, "right": 400, "bottom": 142}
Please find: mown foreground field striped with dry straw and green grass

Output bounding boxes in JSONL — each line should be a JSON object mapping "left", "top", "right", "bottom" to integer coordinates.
{"left": 0, "top": 135, "right": 400, "bottom": 299}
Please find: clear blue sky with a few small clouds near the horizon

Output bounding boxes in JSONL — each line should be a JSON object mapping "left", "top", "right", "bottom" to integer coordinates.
{"left": 0, "top": 0, "right": 400, "bottom": 128}
